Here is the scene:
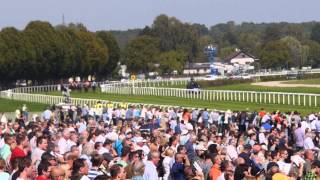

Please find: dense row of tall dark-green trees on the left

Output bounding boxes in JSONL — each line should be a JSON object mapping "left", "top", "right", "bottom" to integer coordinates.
{"left": 0, "top": 21, "right": 120, "bottom": 83}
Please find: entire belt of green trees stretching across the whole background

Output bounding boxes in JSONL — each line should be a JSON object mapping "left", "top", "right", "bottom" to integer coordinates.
{"left": 0, "top": 15, "right": 320, "bottom": 82}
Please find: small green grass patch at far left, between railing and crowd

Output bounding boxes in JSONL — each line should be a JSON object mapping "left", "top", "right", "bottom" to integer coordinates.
{"left": 0, "top": 98, "right": 46, "bottom": 112}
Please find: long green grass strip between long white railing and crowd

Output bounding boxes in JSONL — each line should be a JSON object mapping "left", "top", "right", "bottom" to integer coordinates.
{"left": 33, "top": 91, "right": 318, "bottom": 114}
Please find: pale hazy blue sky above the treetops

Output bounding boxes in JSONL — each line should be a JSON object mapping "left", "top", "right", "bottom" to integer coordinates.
{"left": 0, "top": 0, "right": 320, "bottom": 31}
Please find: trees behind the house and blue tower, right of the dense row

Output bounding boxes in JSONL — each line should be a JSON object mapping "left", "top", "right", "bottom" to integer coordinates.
{"left": 118, "top": 15, "right": 320, "bottom": 73}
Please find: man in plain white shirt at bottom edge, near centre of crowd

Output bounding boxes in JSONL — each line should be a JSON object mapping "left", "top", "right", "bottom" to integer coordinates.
{"left": 143, "top": 152, "right": 160, "bottom": 180}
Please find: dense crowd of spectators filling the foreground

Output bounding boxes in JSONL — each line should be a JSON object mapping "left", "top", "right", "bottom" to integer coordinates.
{"left": 0, "top": 104, "right": 320, "bottom": 180}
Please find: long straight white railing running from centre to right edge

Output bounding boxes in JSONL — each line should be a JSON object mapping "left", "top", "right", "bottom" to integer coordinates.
{"left": 101, "top": 85, "right": 320, "bottom": 107}
